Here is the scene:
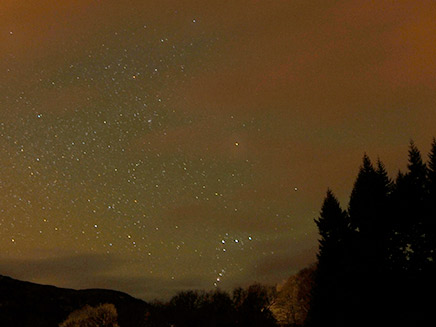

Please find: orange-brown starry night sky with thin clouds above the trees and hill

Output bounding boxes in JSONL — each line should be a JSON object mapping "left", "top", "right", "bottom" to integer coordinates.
{"left": 0, "top": 0, "right": 436, "bottom": 300}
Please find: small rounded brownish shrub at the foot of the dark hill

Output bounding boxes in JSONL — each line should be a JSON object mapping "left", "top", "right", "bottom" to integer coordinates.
{"left": 59, "top": 303, "right": 119, "bottom": 327}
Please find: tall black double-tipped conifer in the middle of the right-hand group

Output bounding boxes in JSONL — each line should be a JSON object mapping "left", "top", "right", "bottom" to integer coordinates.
{"left": 348, "top": 154, "right": 392, "bottom": 324}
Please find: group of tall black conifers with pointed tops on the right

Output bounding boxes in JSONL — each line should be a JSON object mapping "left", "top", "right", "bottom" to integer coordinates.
{"left": 306, "top": 139, "right": 436, "bottom": 327}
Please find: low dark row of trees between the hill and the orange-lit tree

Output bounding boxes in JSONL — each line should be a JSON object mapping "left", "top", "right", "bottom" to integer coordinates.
{"left": 146, "top": 284, "right": 276, "bottom": 327}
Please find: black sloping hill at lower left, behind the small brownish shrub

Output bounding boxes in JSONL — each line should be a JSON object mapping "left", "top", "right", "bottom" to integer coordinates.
{"left": 0, "top": 275, "right": 149, "bottom": 327}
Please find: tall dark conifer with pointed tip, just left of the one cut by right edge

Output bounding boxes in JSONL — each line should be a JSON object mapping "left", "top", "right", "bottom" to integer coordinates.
{"left": 388, "top": 142, "right": 434, "bottom": 325}
